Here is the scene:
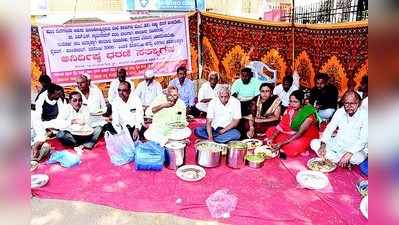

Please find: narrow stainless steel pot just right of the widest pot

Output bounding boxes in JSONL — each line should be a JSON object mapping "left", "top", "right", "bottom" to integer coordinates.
{"left": 227, "top": 141, "right": 247, "bottom": 169}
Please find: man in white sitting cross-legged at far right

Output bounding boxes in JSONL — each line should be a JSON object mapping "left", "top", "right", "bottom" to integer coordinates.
{"left": 311, "top": 91, "right": 368, "bottom": 167}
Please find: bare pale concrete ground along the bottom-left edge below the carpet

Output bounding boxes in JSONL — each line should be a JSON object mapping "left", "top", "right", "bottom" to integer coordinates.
{"left": 31, "top": 198, "right": 225, "bottom": 225}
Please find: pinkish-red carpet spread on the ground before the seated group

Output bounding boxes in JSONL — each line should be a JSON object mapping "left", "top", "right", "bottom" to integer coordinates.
{"left": 33, "top": 120, "right": 367, "bottom": 225}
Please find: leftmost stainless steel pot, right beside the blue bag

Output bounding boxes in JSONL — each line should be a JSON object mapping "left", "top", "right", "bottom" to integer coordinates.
{"left": 164, "top": 141, "right": 186, "bottom": 170}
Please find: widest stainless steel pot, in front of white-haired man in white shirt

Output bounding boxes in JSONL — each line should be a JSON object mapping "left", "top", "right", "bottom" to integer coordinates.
{"left": 195, "top": 141, "right": 227, "bottom": 167}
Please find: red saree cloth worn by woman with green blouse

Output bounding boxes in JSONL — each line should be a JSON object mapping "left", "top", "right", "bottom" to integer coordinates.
{"left": 266, "top": 108, "right": 319, "bottom": 157}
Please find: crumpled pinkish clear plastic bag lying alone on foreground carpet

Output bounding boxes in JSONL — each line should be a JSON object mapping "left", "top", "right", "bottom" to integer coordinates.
{"left": 206, "top": 189, "right": 238, "bottom": 218}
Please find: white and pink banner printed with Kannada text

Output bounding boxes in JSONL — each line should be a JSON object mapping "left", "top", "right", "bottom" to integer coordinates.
{"left": 40, "top": 16, "right": 191, "bottom": 84}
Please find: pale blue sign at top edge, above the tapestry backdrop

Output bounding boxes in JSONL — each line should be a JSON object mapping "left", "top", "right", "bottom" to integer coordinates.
{"left": 125, "top": 0, "right": 205, "bottom": 11}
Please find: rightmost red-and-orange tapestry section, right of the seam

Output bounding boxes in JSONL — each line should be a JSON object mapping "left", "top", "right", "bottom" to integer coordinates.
{"left": 295, "top": 22, "right": 368, "bottom": 94}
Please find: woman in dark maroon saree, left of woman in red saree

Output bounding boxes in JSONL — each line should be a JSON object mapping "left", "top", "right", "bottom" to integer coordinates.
{"left": 243, "top": 83, "right": 281, "bottom": 138}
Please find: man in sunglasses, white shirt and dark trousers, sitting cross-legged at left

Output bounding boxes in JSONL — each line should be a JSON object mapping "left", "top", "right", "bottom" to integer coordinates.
{"left": 56, "top": 91, "right": 102, "bottom": 149}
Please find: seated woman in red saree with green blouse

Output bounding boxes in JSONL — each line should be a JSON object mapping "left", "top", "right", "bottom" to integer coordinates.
{"left": 265, "top": 90, "right": 319, "bottom": 157}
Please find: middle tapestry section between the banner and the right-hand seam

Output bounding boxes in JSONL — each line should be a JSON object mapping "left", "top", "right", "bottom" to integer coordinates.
{"left": 201, "top": 13, "right": 292, "bottom": 83}
